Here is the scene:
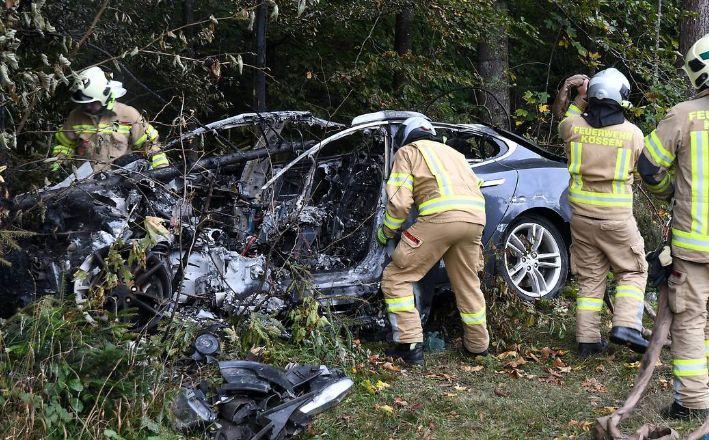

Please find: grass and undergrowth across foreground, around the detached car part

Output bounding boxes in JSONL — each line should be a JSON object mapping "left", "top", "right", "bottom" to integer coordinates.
{"left": 0, "top": 287, "right": 697, "bottom": 440}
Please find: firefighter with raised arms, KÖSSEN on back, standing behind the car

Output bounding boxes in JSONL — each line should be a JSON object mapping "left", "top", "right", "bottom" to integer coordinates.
{"left": 559, "top": 68, "right": 648, "bottom": 357}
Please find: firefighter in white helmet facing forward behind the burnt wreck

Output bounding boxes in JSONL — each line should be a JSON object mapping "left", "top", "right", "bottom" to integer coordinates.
{"left": 52, "top": 66, "right": 169, "bottom": 171}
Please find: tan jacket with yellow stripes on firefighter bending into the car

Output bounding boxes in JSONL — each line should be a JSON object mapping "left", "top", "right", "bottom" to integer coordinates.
{"left": 384, "top": 140, "right": 485, "bottom": 232}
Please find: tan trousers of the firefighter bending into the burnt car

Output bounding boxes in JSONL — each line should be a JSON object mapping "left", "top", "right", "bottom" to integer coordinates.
{"left": 381, "top": 218, "right": 490, "bottom": 353}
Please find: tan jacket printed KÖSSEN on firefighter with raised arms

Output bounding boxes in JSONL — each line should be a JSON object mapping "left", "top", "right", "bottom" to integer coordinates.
{"left": 559, "top": 115, "right": 643, "bottom": 220}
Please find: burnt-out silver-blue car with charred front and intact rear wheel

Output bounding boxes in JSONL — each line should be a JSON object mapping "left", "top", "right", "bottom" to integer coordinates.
{"left": 0, "top": 111, "right": 570, "bottom": 323}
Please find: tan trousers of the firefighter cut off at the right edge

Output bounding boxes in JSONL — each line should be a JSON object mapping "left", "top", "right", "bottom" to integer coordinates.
{"left": 668, "top": 257, "right": 709, "bottom": 409}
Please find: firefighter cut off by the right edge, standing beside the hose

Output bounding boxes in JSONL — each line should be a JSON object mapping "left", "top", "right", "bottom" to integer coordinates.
{"left": 638, "top": 35, "right": 709, "bottom": 419}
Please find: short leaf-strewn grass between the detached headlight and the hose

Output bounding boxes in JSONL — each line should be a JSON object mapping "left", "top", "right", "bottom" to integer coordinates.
{"left": 310, "top": 288, "right": 699, "bottom": 439}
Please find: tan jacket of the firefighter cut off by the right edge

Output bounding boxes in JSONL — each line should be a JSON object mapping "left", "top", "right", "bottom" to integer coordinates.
{"left": 641, "top": 90, "right": 709, "bottom": 263}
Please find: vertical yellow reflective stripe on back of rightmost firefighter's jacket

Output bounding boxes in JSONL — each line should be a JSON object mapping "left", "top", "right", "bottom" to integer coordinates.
{"left": 690, "top": 131, "right": 709, "bottom": 235}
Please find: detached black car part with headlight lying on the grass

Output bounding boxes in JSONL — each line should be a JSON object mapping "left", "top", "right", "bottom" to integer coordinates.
{"left": 172, "top": 360, "right": 354, "bottom": 440}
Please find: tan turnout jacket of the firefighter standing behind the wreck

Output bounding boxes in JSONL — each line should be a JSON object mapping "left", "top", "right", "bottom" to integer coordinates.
{"left": 52, "top": 102, "right": 168, "bottom": 171}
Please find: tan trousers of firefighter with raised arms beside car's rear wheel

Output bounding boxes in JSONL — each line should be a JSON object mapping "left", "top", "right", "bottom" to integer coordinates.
{"left": 571, "top": 214, "right": 647, "bottom": 343}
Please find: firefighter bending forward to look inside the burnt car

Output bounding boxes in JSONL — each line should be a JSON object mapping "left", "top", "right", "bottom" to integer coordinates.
{"left": 377, "top": 117, "right": 489, "bottom": 364}
